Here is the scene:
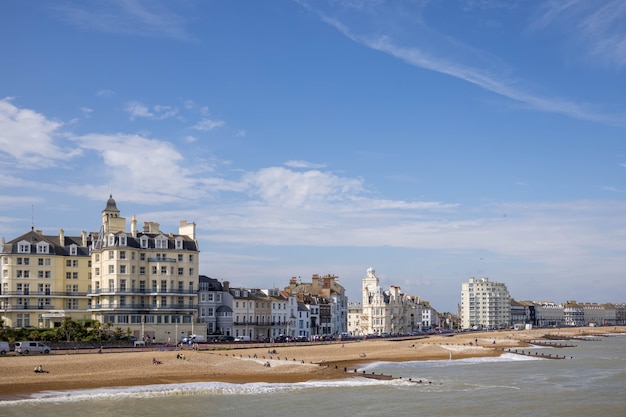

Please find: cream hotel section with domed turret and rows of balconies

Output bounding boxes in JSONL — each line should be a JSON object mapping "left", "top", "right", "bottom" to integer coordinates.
{"left": 87, "top": 196, "right": 197, "bottom": 342}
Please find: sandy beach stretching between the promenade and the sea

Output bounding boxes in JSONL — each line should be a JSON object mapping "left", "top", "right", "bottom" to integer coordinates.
{"left": 0, "top": 327, "right": 626, "bottom": 399}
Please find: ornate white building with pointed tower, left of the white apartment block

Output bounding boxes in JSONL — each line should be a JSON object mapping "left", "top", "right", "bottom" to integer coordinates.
{"left": 353, "top": 267, "right": 422, "bottom": 336}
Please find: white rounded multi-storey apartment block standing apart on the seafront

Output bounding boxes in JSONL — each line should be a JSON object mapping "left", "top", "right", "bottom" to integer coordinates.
{"left": 461, "top": 277, "right": 511, "bottom": 329}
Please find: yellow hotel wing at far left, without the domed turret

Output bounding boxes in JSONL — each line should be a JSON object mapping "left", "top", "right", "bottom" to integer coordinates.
{"left": 0, "top": 226, "right": 91, "bottom": 328}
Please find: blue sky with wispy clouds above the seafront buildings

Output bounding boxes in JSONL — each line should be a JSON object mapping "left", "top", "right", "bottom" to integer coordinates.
{"left": 0, "top": 0, "right": 626, "bottom": 311}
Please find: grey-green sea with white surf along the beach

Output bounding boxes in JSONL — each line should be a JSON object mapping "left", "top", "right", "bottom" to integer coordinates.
{"left": 0, "top": 334, "right": 626, "bottom": 417}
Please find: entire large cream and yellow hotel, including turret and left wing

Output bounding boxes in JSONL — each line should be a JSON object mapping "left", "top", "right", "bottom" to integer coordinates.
{"left": 0, "top": 197, "right": 199, "bottom": 342}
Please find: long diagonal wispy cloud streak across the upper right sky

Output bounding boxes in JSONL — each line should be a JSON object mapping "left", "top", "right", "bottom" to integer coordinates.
{"left": 300, "top": 1, "right": 626, "bottom": 126}
